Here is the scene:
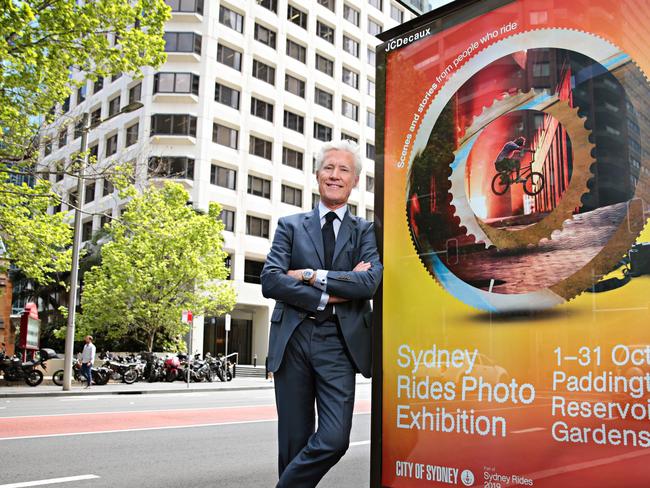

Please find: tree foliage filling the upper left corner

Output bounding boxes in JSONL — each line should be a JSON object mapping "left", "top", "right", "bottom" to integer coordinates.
{"left": 0, "top": 0, "right": 170, "bottom": 281}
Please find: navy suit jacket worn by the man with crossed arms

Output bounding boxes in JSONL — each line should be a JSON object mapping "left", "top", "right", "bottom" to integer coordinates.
{"left": 261, "top": 207, "right": 383, "bottom": 378}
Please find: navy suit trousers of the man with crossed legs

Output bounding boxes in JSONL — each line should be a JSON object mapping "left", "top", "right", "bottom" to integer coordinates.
{"left": 274, "top": 319, "right": 356, "bottom": 488}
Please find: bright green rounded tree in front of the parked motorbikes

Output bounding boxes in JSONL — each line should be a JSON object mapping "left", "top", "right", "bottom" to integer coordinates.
{"left": 78, "top": 182, "right": 236, "bottom": 351}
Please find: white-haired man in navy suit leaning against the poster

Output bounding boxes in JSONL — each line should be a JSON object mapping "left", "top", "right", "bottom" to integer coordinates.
{"left": 261, "top": 141, "right": 382, "bottom": 488}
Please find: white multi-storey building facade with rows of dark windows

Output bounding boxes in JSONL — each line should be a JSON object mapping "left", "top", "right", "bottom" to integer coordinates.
{"left": 42, "top": 0, "right": 412, "bottom": 364}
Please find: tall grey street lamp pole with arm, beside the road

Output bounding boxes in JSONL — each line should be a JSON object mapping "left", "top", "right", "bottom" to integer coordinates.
{"left": 63, "top": 102, "right": 143, "bottom": 391}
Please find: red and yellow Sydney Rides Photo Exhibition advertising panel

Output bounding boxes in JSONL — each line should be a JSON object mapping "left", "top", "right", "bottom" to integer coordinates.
{"left": 372, "top": 0, "right": 650, "bottom": 487}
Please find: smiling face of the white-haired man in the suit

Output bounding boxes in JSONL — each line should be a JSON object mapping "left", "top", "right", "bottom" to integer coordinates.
{"left": 316, "top": 149, "right": 359, "bottom": 208}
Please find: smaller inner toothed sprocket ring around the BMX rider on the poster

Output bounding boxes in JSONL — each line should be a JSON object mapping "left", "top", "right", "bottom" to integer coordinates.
{"left": 449, "top": 90, "right": 596, "bottom": 249}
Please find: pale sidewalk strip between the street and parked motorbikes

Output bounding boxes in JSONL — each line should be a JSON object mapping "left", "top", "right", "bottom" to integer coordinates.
{"left": 0, "top": 375, "right": 371, "bottom": 398}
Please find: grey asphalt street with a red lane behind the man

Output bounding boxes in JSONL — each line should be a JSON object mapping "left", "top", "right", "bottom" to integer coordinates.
{"left": 0, "top": 384, "right": 370, "bottom": 488}
